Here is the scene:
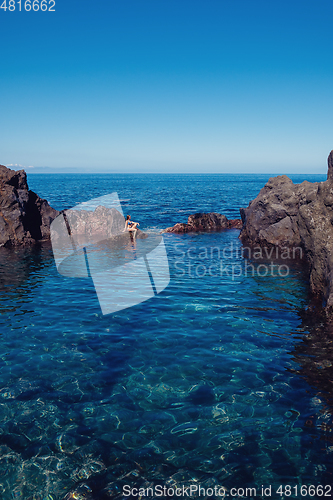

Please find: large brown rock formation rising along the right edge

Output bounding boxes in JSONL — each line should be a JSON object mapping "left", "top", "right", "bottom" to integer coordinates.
{"left": 240, "top": 151, "right": 333, "bottom": 316}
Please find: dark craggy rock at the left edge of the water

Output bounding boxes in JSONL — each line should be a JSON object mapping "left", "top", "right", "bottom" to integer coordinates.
{"left": 0, "top": 165, "right": 59, "bottom": 247}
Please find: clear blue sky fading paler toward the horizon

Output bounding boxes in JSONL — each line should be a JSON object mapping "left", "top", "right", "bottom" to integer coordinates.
{"left": 0, "top": 0, "right": 333, "bottom": 173}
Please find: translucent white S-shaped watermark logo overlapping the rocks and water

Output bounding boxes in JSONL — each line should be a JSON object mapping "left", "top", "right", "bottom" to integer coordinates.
{"left": 51, "top": 193, "right": 170, "bottom": 315}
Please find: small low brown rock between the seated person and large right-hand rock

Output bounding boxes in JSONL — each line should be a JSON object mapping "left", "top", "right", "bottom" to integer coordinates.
{"left": 162, "top": 212, "right": 242, "bottom": 233}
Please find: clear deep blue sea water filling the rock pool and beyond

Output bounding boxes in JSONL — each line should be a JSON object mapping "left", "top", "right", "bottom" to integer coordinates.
{"left": 0, "top": 174, "right": 333, "bottom": 500}
